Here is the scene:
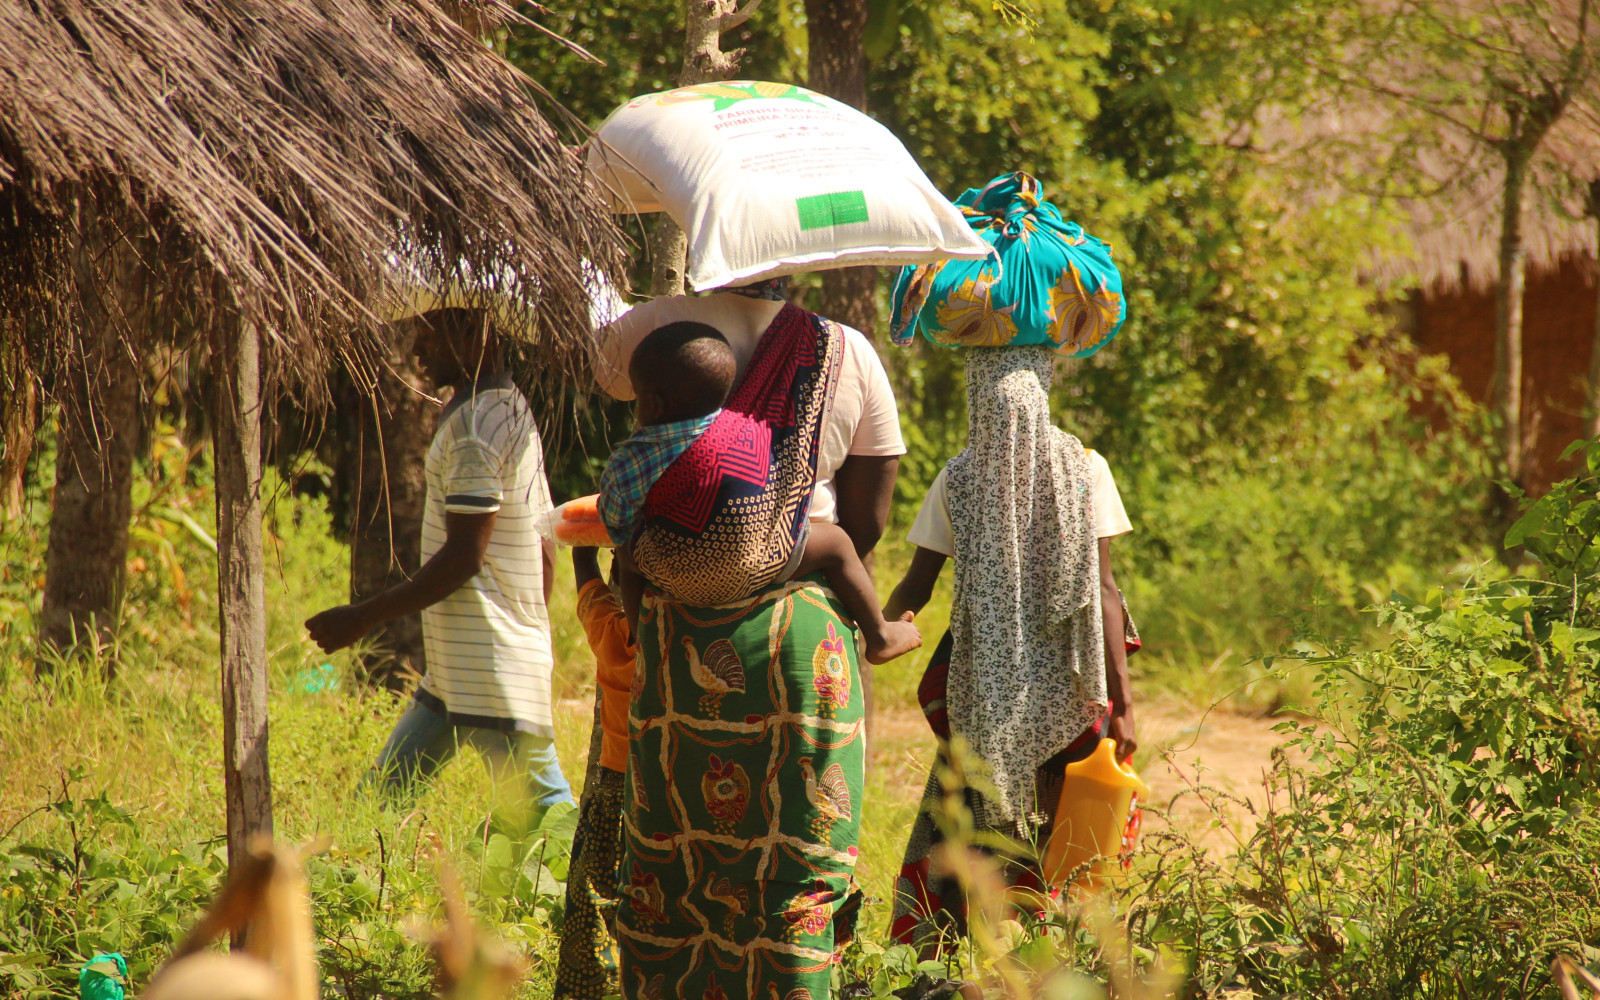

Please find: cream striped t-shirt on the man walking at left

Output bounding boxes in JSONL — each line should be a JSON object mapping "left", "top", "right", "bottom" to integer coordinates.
{"left": 418, "top": 387, "right": 554, "bottom": 736}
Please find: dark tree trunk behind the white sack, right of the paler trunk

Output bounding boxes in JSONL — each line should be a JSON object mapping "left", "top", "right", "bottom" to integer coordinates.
{"left": 805, "top": 0, "right": 880, "bottom": 336}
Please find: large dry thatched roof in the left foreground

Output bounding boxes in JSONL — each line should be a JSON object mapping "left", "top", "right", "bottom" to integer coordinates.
{"left": 0, "top": 0, "right": 624, "bottom": 398}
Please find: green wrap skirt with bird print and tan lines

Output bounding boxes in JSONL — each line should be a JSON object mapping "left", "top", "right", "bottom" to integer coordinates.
{"left": 616, "top": 579, "right": 866, "bottom": 1000}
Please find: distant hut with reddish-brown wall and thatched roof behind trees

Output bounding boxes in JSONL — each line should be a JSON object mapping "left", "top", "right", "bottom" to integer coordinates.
{"left": 1235, "top": 94, "right": 1600, "bottom": 491}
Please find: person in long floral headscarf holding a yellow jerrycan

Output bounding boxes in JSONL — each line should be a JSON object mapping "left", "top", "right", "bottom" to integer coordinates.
{"left": 885, "top": 346, "right": 1136, "bottom": 947}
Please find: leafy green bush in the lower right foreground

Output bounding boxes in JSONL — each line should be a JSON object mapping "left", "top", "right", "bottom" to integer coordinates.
{"left": 1134, "top": 446, "right": 1600, "bottom": 997}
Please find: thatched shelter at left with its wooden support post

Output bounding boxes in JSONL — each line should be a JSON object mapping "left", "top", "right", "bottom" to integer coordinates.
{"left": 0, "top": 0, "right": 622, "bottom": 870}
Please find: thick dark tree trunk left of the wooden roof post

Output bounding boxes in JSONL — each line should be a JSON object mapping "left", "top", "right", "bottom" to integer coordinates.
{"left": 38, "top": 226, "right": 142, "bottom": 662}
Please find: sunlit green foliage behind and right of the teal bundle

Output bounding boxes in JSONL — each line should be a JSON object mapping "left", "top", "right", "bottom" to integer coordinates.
{"left": 874, "top": 2, "right": 1486, "bottom": 702}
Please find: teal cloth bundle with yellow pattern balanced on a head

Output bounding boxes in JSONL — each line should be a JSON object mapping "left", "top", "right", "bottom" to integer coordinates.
{"left": 890, "top": 173, "right": 1128, "bottom": 357}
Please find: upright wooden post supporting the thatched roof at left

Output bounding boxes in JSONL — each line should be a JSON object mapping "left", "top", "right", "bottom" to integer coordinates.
{"left": 211, "top": 318, "right": 272, "bottom": 915}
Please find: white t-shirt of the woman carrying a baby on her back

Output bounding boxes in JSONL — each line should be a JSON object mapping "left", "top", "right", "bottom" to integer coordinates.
{"left": 595, "top": 293, "right": 906, "bottom": 522}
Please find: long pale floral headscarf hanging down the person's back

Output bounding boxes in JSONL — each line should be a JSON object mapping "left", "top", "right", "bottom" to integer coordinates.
{"left": 946, "top": 347, "right": 1106, "bottom": 837}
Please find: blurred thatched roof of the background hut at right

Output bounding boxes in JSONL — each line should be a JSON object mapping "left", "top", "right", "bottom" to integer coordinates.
{"left": 1235, "top": 0, "right": 1600, "bottom": 291}
